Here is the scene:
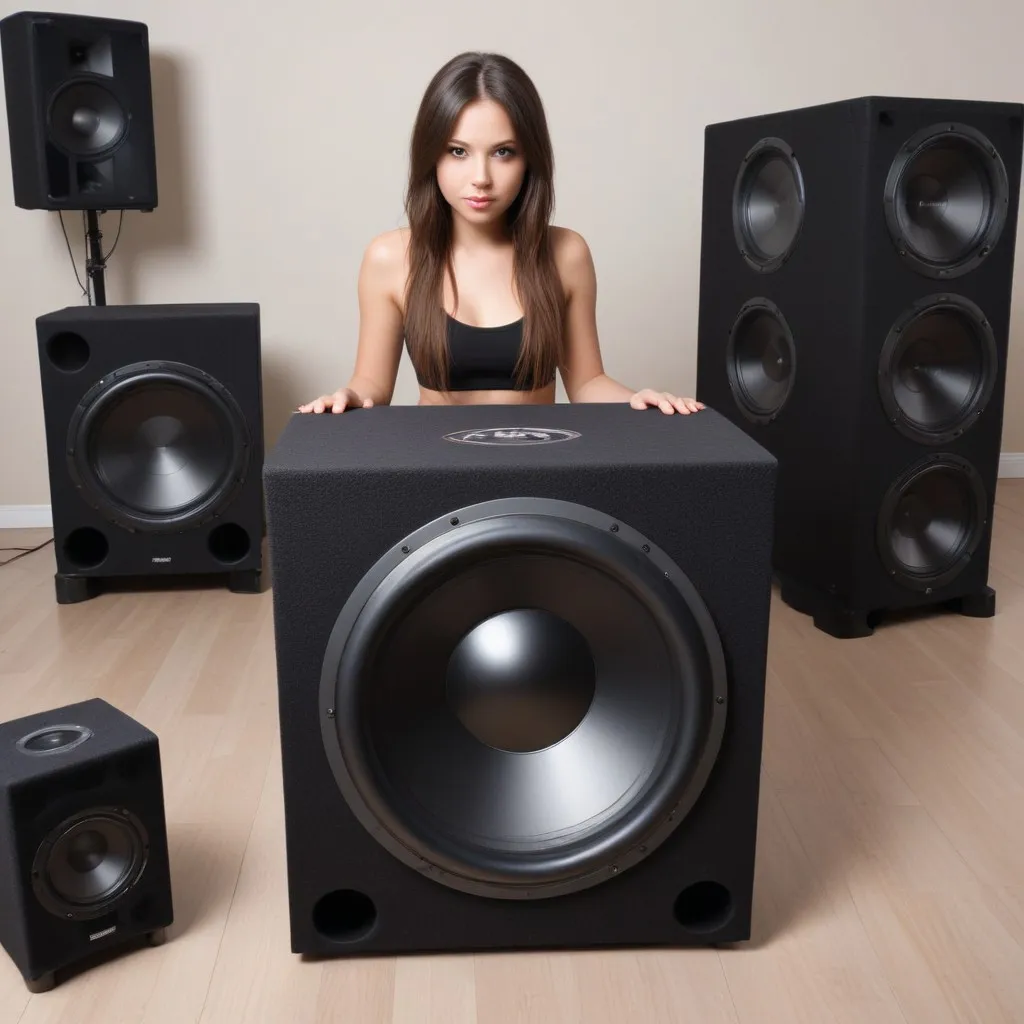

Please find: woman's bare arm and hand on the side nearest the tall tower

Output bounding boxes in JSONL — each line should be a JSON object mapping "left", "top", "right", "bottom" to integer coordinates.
{"left": 555, "top": 228, "right": 703, "bottom": 414}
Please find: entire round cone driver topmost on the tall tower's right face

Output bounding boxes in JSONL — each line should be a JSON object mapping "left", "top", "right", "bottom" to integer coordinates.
{"left": 885, "top": 124, "right": 1010, "bottom": 278}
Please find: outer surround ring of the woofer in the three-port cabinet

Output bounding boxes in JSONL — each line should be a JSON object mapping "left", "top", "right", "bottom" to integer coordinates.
{"left": 66, "top": 359, "right": 252, "bottom": 532}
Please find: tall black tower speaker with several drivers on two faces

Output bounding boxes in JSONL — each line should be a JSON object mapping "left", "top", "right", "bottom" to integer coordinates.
{"left": 697, "top": 97, "right": 1024, "bottom": 637}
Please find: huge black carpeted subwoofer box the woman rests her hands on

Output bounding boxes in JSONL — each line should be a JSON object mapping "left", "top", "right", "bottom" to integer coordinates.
{"left": 264, "top": 404, "right": 775, "bottom": 955}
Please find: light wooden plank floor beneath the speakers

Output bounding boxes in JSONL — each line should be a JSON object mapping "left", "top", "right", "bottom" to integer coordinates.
{"left": 0, "top": 481, "right": 1024, "bottom": 1024}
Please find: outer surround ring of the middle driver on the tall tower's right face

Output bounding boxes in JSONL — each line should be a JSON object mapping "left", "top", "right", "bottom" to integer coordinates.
{"left": 879, "top": 293, "right": 998, "bottom": 444}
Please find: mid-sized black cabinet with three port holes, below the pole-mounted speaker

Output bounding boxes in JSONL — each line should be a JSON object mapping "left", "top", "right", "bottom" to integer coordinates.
{"left": 36, "top": 303, "right": 263, "bottom": 603}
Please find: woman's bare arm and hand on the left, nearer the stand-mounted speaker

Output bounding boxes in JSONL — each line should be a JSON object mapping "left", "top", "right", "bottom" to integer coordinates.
{"left": 299, "top": 231, "right": 406, "bottom": 413}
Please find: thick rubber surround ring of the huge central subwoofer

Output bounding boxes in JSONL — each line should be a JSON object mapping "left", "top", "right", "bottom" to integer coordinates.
{"left": 319, "top": 498, "right": 728, "bottom": 899}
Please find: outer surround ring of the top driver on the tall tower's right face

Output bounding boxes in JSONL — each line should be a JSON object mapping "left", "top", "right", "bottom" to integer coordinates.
{"left": 883, "top": 121, "right": 1010, "bottom": 279}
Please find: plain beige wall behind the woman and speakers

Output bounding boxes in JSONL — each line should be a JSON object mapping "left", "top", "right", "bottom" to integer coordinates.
{"left": 0, "top": 0, "right": 1024, "bottom": 506}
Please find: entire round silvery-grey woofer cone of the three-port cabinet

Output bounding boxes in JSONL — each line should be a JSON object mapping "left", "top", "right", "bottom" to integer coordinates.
{"left": 68, "top": 361, "right": 249, "bottom": 529}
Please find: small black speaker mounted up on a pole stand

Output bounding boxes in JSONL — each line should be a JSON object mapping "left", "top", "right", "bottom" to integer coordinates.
{"left": 0, "top": 11, "right": 157, "bottom": 210}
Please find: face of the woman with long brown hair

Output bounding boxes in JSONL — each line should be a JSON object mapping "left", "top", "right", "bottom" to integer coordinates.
{"left": 437, "top": 99, "right": 526, "bottom": 226}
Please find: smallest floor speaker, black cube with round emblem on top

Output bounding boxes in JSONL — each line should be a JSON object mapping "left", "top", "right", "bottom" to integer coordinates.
{"left": 0, "top": 698, "right": 173, "bottom": 992}
